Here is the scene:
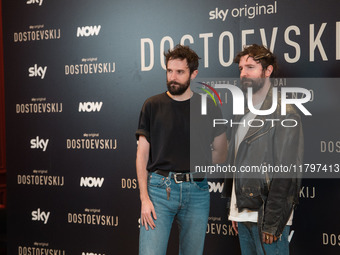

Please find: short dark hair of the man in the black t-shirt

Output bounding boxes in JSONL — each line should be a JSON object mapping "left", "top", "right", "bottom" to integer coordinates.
{"left": 164, "top": 44, "right": 200, "bottom": 74}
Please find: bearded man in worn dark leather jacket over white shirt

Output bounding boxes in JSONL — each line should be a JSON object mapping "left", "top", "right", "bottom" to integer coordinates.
{"left": 223, "top": 44, "right": 303, "bottom": 254}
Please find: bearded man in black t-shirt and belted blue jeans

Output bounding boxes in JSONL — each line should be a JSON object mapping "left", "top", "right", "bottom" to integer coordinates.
{"left": 136, "top": 45, "right": 227, "bottom": 255}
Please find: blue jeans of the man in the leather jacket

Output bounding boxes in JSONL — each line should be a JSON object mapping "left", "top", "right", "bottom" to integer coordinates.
{"left": 238, "top": 222, "right": 290, "bottom": 255}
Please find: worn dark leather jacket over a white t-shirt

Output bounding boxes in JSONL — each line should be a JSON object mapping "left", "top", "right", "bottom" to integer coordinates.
{"left": 222, "top": 88, "right": 304, "bottom": 237}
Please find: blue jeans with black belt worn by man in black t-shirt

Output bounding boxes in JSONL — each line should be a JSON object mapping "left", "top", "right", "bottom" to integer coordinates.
{"left": 139, "top": 172, "right": 210, "bottom": 255}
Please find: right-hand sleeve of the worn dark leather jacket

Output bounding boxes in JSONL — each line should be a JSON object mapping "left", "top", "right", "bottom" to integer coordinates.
{"left": 262, "top": 114, "right": 303, "bottom": 237}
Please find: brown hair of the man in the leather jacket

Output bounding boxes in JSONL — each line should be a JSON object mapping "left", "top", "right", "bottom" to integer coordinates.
{"left": 234, "top": 44, "right": 278, "bottom": 77}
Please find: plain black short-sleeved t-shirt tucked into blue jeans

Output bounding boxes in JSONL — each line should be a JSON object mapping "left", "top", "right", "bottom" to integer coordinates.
{"left": 136, "top": 93, "right": 225, "bottom": 172}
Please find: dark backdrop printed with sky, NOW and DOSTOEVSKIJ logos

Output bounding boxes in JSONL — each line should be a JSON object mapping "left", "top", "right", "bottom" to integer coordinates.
{"left": 2, "top": 0, "right": 340, "bottom": 255}
